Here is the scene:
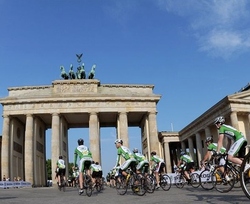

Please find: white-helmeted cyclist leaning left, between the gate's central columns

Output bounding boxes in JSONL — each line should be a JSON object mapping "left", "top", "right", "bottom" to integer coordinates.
{"left": 115, "top": 139, "right": 136, "bottom": 179}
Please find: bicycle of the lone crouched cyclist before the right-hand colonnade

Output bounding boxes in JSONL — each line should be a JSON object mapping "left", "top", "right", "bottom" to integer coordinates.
{"left": 175, "top": 168, "right": 200, "bottom": 188}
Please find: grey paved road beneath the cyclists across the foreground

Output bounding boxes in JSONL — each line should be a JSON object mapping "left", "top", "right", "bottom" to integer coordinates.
{"left": 0, "top": 186, "right": 250, "bottom": 204}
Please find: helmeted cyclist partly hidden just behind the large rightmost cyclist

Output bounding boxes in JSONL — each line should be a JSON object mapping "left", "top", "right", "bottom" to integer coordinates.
{"left": 200, "top": 137, "right": 226, "bottom": 168}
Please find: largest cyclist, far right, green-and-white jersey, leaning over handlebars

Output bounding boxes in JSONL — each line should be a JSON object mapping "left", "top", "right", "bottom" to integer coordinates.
{"left": 214, "top": 116, "right": 250, "bottom": 172}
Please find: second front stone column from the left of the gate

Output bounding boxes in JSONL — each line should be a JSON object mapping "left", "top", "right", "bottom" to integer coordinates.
{"left": 24, "top": 114, "right": 34, "bottom": 185}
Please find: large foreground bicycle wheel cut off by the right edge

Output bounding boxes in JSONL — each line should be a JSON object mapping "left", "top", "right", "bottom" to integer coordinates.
{"left": 240, "top": 152, "right": 250, "bottom": 199}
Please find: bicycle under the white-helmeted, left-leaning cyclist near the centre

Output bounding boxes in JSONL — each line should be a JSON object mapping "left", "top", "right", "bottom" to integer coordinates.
{"left": 116, "top": 164, "right": 147, "bottom": 196}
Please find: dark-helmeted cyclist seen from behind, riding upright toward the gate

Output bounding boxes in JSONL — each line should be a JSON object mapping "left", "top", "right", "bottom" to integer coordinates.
{"left": 74, "top": 138, "right": 92, "bottom": 195}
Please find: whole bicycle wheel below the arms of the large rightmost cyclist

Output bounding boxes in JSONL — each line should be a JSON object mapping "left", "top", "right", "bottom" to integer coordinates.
{"left": 212, "top": 166, "right": 235, "bottom": 193}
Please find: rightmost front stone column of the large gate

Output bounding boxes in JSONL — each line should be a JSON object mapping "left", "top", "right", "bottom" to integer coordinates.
{"left": 148, "top": 112, "right": 160, "bottom": 154}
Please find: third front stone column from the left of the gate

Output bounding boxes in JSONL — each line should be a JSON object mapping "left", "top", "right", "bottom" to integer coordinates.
{"left": 51, "top": 113, "right": 61, "bottom": 185}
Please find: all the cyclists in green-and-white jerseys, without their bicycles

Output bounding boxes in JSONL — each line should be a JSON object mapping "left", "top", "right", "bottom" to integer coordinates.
{"left": 56, "top": 116, "right": 250, "bottom": 194}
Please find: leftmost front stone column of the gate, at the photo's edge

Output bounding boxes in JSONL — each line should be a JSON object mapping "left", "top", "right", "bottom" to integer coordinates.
{"left": 1, "top": 115, "right": 10, "bottom": 178}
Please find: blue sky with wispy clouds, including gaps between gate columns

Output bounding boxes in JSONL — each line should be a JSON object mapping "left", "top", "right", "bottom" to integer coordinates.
{"left": 0, "top": 0, "right": 250, "bottom": 173}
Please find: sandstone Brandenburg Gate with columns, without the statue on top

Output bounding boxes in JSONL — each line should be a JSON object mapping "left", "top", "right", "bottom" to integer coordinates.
{"left": 0, "top": 79, "right": 161, "bottom": 186}
